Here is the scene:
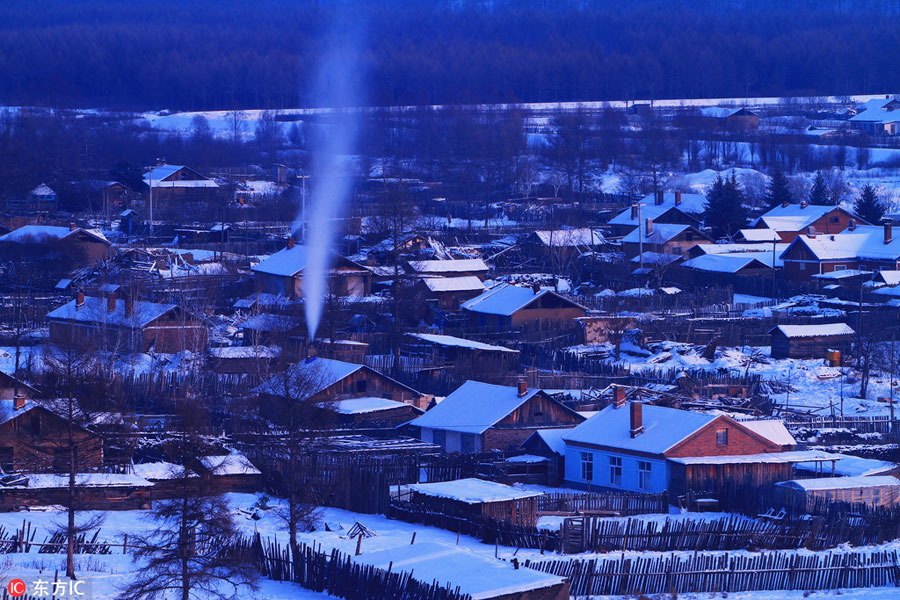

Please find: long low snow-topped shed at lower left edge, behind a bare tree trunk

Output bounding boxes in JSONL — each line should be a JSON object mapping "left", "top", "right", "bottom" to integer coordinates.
{"left": 0, "top": 473, "right": 153, "bottom": 511}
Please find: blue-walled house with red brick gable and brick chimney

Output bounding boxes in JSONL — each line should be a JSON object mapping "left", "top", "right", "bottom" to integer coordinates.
{"left": 563, "top": 401, "right": 816, "bottom": 499}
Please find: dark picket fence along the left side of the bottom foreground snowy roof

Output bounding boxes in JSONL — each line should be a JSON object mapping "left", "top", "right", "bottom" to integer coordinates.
{"left": 243, "top": 534, "right": 471, "bottom": 600}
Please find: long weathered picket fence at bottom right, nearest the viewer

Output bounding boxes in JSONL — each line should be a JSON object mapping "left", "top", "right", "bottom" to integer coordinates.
{"left": 524, "top": 550, "right": 900, "bottom": 597}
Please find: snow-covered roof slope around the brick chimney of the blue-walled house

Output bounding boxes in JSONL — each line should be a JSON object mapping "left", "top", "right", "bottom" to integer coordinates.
{"left": 563, "top": 404, "right": 717, "bottom": 454}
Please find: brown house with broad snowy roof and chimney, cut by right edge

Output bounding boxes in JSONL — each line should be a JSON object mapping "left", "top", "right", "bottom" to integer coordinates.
{"left": 781, "top": 222, "right": 900, "bottom": 281}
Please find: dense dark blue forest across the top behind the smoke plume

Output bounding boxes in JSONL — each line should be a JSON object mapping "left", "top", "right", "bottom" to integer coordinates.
{"left": 0, "top": 0, "right": 900, "bottom": 109}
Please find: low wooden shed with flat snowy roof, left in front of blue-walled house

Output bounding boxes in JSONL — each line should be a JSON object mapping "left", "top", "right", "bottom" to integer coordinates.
{"left": 407, "top": 478, "right": 542, "bottom": 527}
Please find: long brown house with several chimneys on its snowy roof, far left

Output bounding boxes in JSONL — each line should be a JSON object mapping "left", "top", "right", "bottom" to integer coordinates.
{"left": 47, "top": 292, "right": 209, "bottom": 354}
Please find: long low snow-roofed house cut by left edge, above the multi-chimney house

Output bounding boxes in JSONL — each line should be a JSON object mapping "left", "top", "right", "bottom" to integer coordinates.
{"left": 0, "top": 223, "right": 112, "bottom": 267}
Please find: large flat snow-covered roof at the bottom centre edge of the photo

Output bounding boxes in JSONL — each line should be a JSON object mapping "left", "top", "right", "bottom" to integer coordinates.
{"left": 353, "top": 542, "right": 569, "bottom": 600}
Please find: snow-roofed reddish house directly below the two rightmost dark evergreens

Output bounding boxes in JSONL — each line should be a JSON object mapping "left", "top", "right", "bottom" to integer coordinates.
{"left": 756, "top": 200, "right": 868, "bottom": 243}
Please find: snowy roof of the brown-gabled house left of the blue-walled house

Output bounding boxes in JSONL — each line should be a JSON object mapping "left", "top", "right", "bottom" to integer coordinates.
{"left": 409, "top": 381, "right": 540, "bottom": 434}
